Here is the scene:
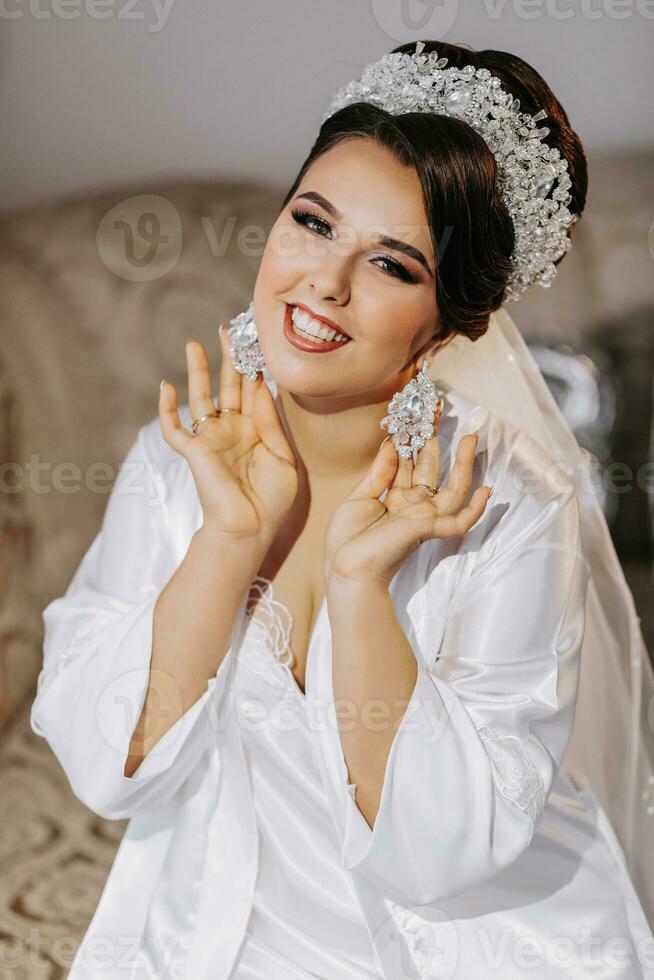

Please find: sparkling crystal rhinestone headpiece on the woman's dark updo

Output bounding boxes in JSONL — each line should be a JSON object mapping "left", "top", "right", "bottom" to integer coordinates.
{"left": 322, "top": 41, "right": 577, "bottom": 300}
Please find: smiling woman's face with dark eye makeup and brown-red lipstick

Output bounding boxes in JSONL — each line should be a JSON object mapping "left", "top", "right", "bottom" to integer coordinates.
{"left": 253, "top": 138, "right": 438, "bottom": 401}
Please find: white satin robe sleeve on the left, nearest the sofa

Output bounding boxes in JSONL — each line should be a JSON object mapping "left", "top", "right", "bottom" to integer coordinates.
{"left": 30, "top": 425, "right": 238, "bottom": 820}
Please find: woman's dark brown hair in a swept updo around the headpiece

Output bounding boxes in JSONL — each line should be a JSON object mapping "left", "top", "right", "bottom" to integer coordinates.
{"left": 282, "top": 41, "right": 588, "bottom": 340}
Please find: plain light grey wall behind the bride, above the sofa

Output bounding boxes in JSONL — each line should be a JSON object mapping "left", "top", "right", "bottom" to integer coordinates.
{"left": 0, "top": 0, "right": 654, "bottom": 210}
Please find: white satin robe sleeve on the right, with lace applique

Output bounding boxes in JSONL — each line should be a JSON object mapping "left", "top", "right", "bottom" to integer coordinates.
{"left": 339, "top": 474, "right": 588, "bottom": 905}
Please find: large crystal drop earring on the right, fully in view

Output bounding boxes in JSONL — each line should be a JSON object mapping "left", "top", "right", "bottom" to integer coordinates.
{"left": 379, "top": 359, "right": 443, "bottom": 462}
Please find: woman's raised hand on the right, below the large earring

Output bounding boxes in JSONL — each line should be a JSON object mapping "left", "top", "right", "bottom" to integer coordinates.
{"left": 324, "top": 423, "right": 492, "bottom": 587}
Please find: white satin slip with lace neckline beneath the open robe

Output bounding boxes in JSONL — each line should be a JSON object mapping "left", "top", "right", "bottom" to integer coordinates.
{"left": 232, "top": 576, "right": 381, "bottom": 980}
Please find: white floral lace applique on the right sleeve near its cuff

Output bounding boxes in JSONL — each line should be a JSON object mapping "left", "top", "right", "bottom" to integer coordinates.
{"left": 478, "top": 725, "right": 545, "bottom": 823}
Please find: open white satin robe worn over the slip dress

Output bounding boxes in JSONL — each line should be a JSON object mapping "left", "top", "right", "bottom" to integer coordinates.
{"left": 31, "top": 382, "right": 654, "bottom": 980}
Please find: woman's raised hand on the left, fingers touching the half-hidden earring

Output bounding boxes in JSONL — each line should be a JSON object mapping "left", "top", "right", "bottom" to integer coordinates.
{"left": 159, "top": 324, "right": 297, "bottom": 554}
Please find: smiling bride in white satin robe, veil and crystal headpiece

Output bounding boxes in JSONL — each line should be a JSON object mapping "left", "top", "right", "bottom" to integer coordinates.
{"left": 31, "top": 42, "right": 654, "bottom": 980}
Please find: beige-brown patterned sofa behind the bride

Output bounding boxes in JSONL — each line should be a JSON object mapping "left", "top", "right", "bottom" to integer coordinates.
{"left": 0, "top": 153, "right": 654, "bottom": 980}
